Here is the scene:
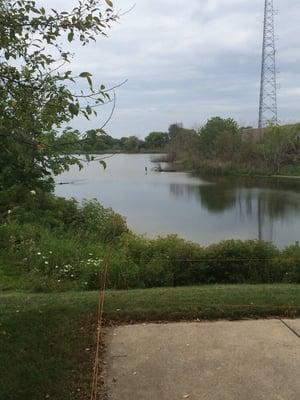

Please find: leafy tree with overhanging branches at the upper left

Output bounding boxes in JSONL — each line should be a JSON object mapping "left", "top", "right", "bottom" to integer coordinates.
{"left": 0, "top": 0, "right": 118, "bottom": 209}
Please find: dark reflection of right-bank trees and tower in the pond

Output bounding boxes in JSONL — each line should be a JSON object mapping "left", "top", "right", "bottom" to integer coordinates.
{"left": 170, "top": 176, "right": 300, "bottom": 241}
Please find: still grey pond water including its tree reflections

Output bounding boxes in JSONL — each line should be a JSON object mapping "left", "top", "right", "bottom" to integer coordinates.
{"left": 56, "top": 154, "right": 300, "bottom": 246}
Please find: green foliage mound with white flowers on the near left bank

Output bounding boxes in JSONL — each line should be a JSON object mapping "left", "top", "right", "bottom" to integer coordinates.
{"left": 0, "top": 195, "right": 127, "bottom": 291}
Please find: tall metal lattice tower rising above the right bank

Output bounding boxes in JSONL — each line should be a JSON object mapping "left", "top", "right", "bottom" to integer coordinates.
{"left": 258, "top": 0, "right": 278, "bottom": 129}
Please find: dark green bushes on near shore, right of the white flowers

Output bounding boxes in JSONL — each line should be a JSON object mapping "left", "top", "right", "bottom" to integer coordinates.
{"left": 108, "top": 234, "right": 300, "bottom": 288}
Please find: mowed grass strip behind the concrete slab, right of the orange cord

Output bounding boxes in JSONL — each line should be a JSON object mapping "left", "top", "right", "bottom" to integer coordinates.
{"left": 105, "top": 284, "right": 300, "bottom": 322}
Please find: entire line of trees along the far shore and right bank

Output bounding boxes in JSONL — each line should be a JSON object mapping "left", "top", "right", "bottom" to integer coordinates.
{"left": 59, "top": 117, "right": 300, "bottom": 175}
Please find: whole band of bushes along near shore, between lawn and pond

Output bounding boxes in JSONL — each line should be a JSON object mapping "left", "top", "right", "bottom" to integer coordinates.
{"left": 0, "top": 212, "right": 300, "bottom": 291}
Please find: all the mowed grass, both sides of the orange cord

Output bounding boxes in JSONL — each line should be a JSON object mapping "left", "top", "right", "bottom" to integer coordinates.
{"left": 0, "top": 285, "right": 300, "bottom": 400}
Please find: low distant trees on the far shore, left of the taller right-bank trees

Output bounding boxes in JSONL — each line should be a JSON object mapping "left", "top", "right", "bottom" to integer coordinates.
{"left": 60, "top": 129, "right": 170, "bottom": 153}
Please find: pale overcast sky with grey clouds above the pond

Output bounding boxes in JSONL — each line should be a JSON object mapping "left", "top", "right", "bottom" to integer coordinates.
{"left": 39, "top": 0, "right": 300, "bottom": 137}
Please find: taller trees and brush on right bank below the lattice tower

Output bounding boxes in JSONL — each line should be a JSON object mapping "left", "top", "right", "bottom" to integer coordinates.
{"left": 168, "top": 117, "right": 300, "bottom": 175}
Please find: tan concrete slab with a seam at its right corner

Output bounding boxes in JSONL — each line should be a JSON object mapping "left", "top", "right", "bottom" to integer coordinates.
{"left": 105, "top": 320, "right": 300, "bottom": 400}
